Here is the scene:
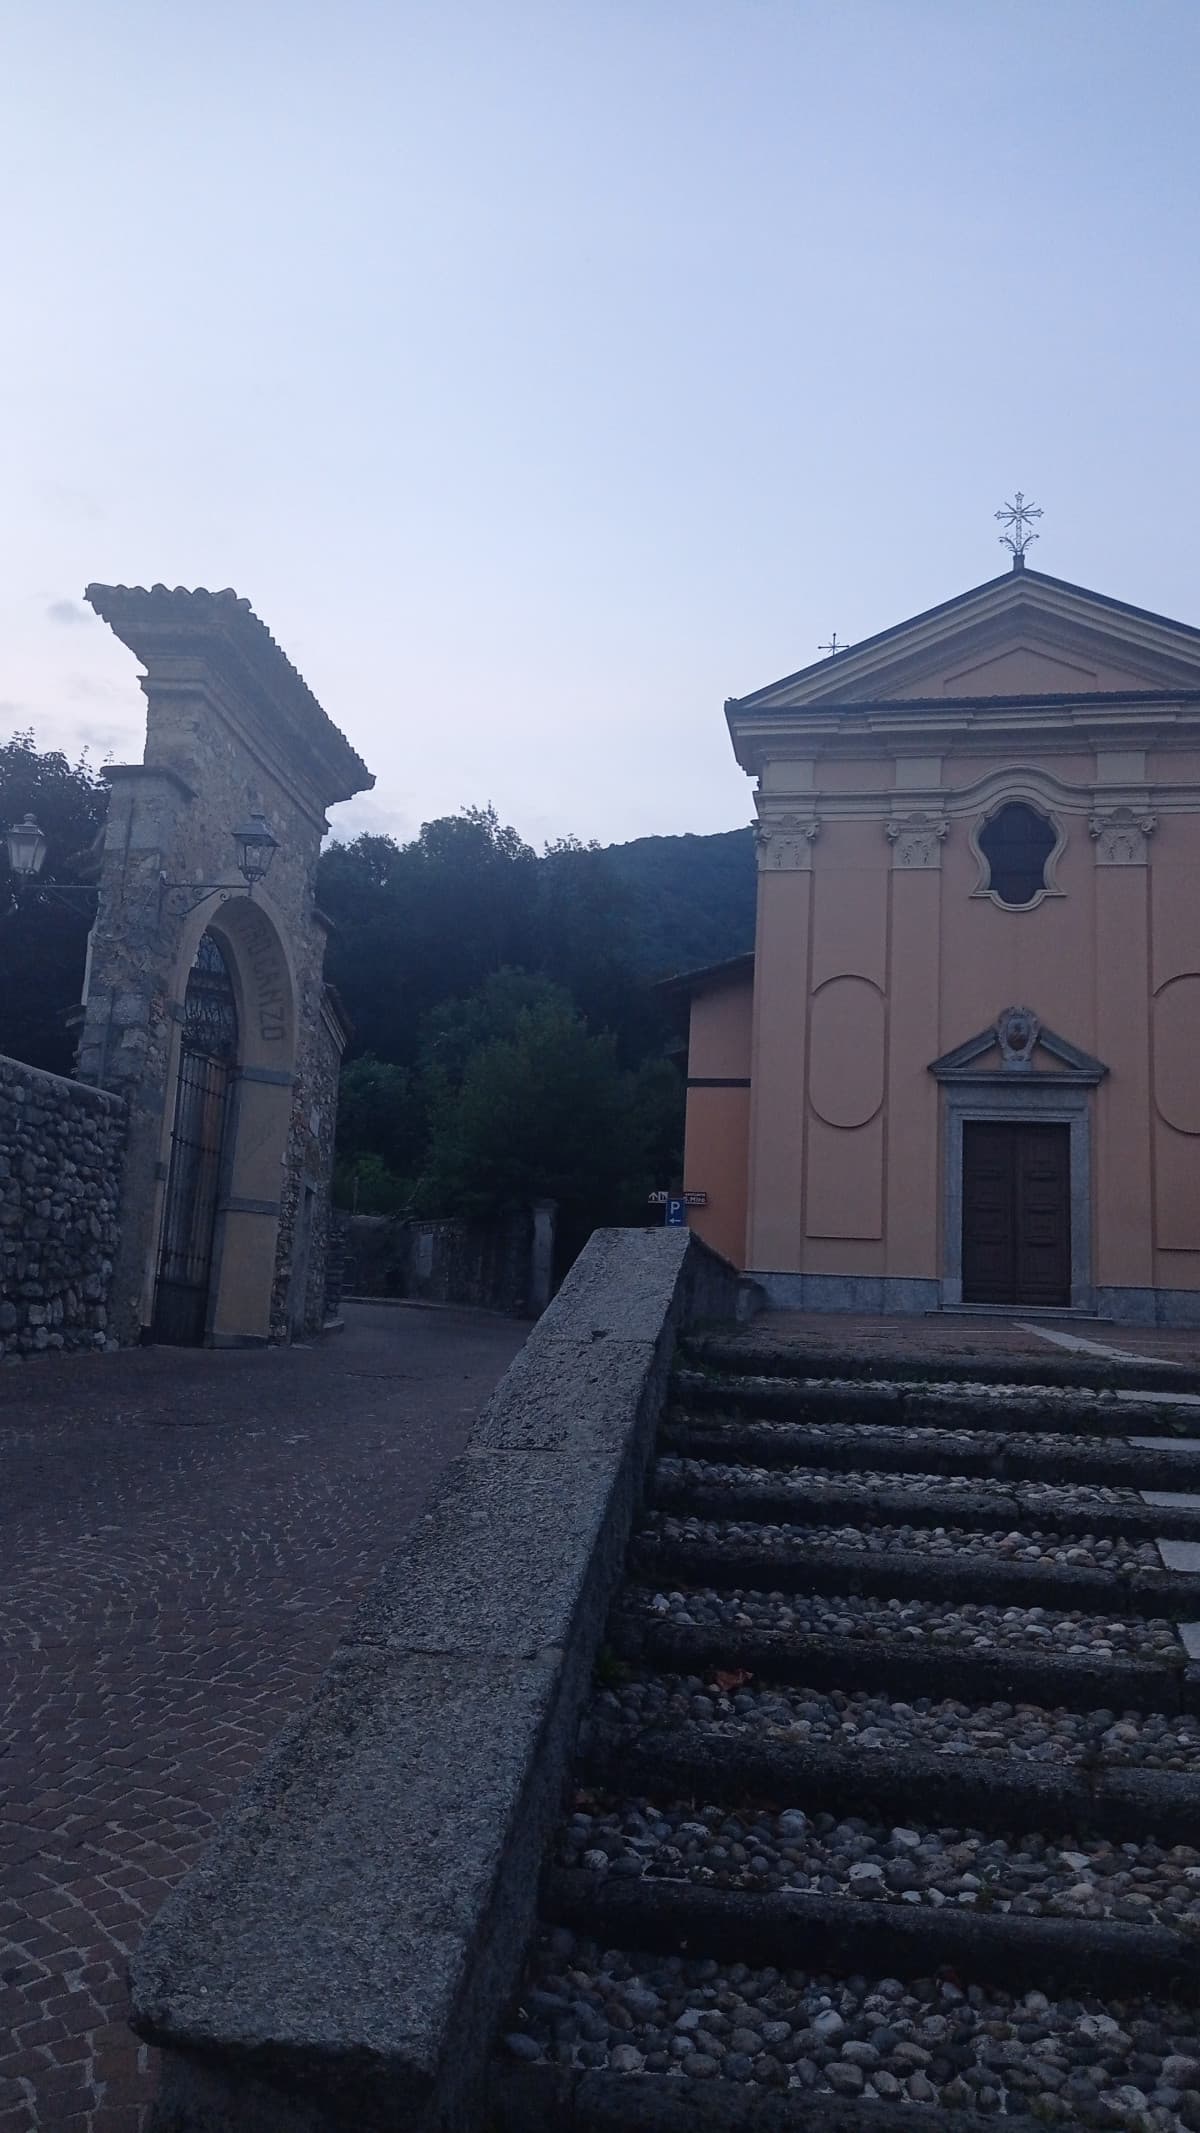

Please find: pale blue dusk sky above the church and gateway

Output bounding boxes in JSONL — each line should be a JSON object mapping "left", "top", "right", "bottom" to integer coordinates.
{"left": 0, "top": 0, "right": 1200, "bottom": 845}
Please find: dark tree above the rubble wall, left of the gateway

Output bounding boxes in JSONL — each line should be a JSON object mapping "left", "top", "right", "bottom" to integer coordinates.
{"left": 0, "top": 732, "right": 109, "bottom": 1073}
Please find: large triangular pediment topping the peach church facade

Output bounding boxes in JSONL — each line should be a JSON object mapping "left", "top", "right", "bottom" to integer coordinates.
{"left": 729, "top": 570, "right": 1200, "bottom": 723}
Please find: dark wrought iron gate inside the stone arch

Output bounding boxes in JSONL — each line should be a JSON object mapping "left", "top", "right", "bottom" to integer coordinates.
{"left": 153, "top": 934, "right": 237, "bottom": 1348}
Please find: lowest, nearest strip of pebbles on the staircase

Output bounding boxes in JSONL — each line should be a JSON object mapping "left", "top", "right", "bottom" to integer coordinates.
{"left": 505, "top": 1928, "right": 1200, "bottom": 2133}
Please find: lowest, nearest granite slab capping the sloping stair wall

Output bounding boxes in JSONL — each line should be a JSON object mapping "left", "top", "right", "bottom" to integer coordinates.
{"left": 130, "top": 1649, "right": 556, "bottom": 2122}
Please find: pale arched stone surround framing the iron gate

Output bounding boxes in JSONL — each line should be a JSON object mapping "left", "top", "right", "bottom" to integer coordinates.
{"left": 153, "top": 892, "right": 296, "bottom": 1348}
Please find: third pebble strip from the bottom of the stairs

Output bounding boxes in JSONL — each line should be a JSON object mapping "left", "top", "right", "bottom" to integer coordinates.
{"left": 593, "top": 1668, "right": 1200, "bottom": 1779}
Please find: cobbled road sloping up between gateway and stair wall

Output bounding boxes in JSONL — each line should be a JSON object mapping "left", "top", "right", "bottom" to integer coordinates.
{"left": 0, "top": 1305, "right": 526, "bottom": 2133}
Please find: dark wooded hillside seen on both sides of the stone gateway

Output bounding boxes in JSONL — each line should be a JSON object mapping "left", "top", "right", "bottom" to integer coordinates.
{"left": 0, "top": 734, "right": 755, "bottom": 1239}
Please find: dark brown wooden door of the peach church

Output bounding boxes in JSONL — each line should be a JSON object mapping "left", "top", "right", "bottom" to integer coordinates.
{"left": 963, "top": 1120, "right": 1070, "bottom": 1310}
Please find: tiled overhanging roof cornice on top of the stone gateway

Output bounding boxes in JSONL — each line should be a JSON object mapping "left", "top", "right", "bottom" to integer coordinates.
{"left": 83, "top": 584, "right": 375, "bottom": 806}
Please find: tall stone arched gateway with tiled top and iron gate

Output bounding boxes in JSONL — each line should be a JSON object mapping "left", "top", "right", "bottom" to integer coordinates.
{"left": 79, "top": 584, "right": 373, "bottom": 1346}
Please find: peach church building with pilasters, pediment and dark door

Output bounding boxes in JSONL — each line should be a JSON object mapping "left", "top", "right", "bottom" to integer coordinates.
{"left": 680, "top": 555, "right": 1200, "bottom": 1325}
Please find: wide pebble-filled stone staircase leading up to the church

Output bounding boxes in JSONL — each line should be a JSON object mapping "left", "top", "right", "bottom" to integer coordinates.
{"left": 494, "top": 1335, "right": 1200, "bottom": 2133}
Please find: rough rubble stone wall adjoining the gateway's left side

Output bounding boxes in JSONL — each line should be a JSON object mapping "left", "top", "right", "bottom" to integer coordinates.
{"left": 0, "top": 1058, "right": 126, "bottom": 1354}
